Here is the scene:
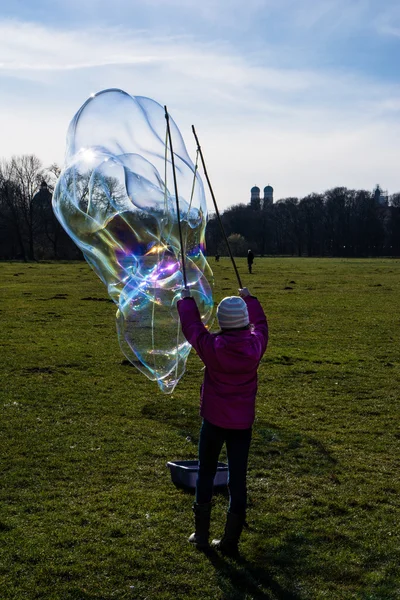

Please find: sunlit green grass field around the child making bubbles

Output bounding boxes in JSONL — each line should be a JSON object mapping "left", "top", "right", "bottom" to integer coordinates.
{"left": 0, "top": 258, "right": 400, "bottom": 600}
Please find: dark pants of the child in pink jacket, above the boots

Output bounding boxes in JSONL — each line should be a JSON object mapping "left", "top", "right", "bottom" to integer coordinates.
{"left": 196, "top": 419, "right": 252, "bottom": 515}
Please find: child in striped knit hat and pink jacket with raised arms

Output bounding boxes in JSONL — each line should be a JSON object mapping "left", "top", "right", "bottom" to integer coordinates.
{"left": 178, "top": 288, "right": 268, "bottom": 555}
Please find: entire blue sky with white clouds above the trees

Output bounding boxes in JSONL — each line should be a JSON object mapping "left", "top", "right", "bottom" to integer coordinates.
{"left": 0, "top": 0, "right": 400, "bottom": 209}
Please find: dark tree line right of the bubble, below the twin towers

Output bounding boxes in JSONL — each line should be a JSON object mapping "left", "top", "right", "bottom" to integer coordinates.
{"left": 206, "top": 187, "right": 400, "bottom": 257}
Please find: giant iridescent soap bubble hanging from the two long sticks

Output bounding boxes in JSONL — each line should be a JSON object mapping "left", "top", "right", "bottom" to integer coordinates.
{"left": 53, "top": 89, "right": 213, "bottom": 393}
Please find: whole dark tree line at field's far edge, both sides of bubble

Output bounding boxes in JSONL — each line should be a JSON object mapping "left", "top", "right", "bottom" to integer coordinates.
{"left": 0, "top": 155, "right": 400, "bottom": 261}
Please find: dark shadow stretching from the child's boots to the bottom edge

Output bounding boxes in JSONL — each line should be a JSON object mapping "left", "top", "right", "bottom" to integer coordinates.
{"left": 204, "top": 548, "right": 301, "bottom": 600}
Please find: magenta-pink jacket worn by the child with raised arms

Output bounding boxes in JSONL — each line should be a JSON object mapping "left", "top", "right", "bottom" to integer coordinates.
{"left": 178, "top": 296, "right": 268, "bottom": 429}
